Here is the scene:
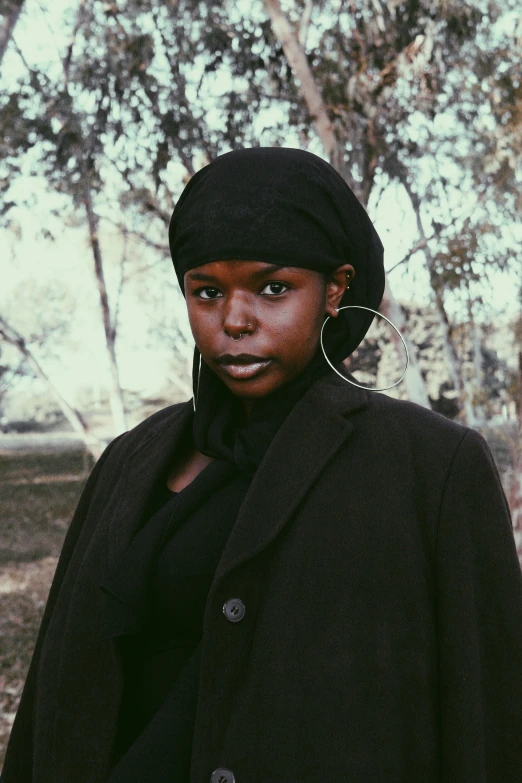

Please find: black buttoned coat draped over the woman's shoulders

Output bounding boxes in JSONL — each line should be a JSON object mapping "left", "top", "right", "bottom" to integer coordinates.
{"left": 2, "top": 372, "right": 522, "bottom": 783}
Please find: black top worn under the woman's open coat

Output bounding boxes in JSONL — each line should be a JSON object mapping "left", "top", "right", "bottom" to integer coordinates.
{"left": 104, "top": 460, "right": 249, "bottom": 783}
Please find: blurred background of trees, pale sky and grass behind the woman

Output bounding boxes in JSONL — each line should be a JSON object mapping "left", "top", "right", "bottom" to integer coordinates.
{"left": 0, "top": 0, "right": 522, "bottom": 772}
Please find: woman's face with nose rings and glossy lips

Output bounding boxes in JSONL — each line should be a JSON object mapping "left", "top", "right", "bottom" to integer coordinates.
{"left": 184, "top": 261, "right": 355, "bottom": 408}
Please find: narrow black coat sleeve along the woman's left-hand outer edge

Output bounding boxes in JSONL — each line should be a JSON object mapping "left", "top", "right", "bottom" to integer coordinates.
{"left": 0, "top": 433, "right": 125, "bottom": 783}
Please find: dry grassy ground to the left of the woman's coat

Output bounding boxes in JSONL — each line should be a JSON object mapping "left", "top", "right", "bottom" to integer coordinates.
{"left": 0, "top": 452, "right": 86, "bottom": 767}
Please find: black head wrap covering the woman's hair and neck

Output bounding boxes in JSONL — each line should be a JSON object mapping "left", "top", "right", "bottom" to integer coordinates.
{"left": 169, "top": 147, "right": 385, "bottom": 475}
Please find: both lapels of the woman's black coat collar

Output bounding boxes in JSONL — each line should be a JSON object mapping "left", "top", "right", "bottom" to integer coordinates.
{"left": 103, "top": 364, "right": 369, "bottom": 589}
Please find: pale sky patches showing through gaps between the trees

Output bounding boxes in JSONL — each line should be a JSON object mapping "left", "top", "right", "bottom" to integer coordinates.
{"left": 0, "top": 0, "right": 522, "bottom": 399}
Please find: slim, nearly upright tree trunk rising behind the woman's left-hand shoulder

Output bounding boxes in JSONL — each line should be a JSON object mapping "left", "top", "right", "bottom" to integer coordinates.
{"left": 84, "top": 176, "right": 127, "bottom": 435}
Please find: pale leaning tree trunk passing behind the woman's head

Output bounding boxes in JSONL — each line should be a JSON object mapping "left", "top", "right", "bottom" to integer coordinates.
{"left": 264, "top": 0, "right": 431, "bottom": 408}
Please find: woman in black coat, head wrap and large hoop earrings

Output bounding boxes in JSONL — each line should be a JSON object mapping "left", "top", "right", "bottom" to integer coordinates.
{"left": 2, "top": 148, "right": 522, "bottom": 783}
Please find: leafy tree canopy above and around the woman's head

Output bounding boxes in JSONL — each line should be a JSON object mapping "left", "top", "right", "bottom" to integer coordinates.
{"left": 0, "top": 0, "right": 522, "bottom": 416}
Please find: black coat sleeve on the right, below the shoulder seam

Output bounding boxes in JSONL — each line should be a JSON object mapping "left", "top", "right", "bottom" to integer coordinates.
{"left": 436, "top": 429, "right": 522, "bottom": 783}
